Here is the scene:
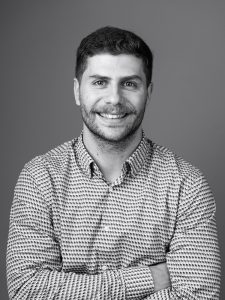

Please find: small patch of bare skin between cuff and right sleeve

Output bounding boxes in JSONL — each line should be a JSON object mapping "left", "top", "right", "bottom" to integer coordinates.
{"left": 150, "top": 263, "right": 171, "bottom": 292}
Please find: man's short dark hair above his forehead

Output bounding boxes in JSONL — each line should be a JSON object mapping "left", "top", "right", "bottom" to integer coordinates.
{"left": 75, "top": 26, "right": 153, "bottom": 85}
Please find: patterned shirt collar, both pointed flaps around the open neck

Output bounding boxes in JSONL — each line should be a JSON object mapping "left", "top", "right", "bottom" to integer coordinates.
{"left": 75, "top": 132, "right": 149, "bottom": 178}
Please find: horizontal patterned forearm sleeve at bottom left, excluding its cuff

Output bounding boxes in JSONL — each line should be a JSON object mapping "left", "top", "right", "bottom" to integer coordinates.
{"left": 9, "top": 269, "right": 125, "bottom": 300}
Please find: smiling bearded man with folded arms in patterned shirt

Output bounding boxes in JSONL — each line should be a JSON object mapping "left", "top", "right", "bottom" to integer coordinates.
{"left": 7, "top": 27, "right": 220, "bottom": 300}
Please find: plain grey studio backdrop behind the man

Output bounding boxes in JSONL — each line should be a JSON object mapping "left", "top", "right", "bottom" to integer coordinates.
{"left": 0, "top": 0, "right": 225, "bottom": 299}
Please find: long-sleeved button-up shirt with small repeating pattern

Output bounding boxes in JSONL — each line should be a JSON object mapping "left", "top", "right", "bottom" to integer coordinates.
{"left": 7, "top": 134, "right": 220, "bottom": 300}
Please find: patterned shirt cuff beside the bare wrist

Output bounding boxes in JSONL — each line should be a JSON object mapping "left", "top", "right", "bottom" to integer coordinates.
{"left": 121, "top": 266, "right": 154, "bottom": 300}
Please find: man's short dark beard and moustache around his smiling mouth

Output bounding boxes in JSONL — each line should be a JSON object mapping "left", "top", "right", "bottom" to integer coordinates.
{"left": 80, "top": 99, "right": 146, "bottom": 144}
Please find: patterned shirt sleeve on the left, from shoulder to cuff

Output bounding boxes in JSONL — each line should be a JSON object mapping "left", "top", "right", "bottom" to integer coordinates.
{"left": 7, "top": 168, "right": 153, "bottom": 300}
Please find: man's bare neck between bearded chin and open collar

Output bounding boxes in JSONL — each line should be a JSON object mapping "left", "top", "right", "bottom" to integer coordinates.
{"left": 83, "top": 127, "right": 142, "bottom": 182}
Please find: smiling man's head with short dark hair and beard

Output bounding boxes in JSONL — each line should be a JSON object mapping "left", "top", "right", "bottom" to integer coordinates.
{"left": 74, "top": 27, "right": 152, "bottom": 143}
